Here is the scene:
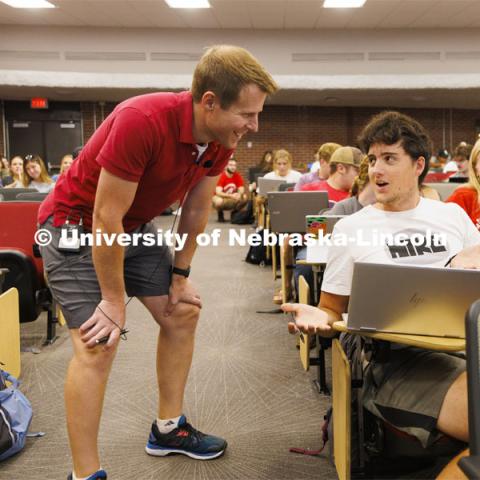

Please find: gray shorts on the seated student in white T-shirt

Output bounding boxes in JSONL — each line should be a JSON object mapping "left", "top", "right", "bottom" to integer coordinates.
{"left": 362, "top": 348, "right": 466, "bottom": 447}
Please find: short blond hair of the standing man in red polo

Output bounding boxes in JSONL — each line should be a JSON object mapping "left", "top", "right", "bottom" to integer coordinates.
{"left": 192, "top": 45, "right": 278, "bottom": 109}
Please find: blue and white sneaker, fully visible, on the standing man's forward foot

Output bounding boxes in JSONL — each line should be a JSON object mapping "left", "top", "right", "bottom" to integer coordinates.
{"left": 145, "top": 415, "right": 227, "bottom": 460}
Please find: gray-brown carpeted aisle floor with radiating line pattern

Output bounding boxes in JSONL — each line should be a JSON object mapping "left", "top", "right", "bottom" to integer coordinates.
{"left": 0, "top": 217, "right": 336, "bottom": 480}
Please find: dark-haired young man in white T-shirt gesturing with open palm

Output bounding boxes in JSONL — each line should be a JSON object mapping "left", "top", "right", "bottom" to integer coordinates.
{"left": 282, "top": 112, "right": 480, "bottom": 456}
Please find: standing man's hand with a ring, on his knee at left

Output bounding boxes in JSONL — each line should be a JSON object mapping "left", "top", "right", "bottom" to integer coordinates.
{"left": 80, "top": 300, "right": 125, "bottom": 349}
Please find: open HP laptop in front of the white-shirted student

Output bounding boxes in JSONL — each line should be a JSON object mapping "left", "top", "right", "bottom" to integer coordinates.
{"left": 345, "top": 262, "right": 480, "bottom": 338}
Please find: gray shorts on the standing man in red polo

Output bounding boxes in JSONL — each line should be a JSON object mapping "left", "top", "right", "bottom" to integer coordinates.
{"left": 40, "top": 218, "right": 172, "bottom": 328}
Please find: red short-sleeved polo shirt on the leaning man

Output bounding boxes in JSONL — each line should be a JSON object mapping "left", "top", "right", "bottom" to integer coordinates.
{"left": 38, "top": 92, "right": 232, "bottom": 232}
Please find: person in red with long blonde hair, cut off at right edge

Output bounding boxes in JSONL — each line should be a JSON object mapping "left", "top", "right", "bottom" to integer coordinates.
{"left": 446, "top": 140, "right": 480, "bottom": 230}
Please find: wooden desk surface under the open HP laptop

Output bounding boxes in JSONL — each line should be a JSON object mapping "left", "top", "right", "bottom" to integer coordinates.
{"left": 333, "top": 321, "right": 465, "bottom": 352}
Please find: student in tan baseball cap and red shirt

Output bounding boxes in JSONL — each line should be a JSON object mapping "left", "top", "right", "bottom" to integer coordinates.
{"left": 300, "top": 147, "right": 365, "bottom": 205}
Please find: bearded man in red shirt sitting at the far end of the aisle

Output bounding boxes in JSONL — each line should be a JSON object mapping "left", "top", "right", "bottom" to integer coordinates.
{"left": 212, "top": 157, "right": 247, "bottom": 222}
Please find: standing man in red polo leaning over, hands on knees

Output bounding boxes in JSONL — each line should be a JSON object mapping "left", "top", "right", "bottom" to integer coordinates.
{"left": 39, "top": 46, "right": 277, "bottom": 480}
